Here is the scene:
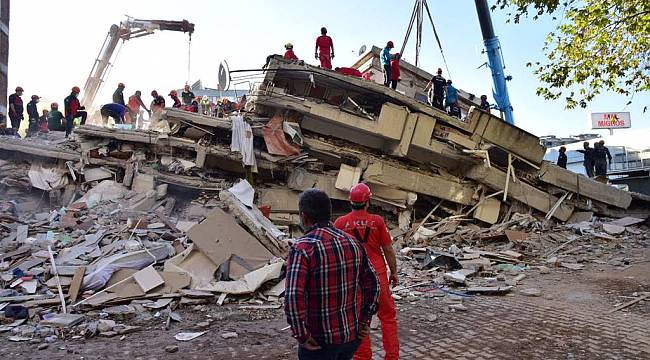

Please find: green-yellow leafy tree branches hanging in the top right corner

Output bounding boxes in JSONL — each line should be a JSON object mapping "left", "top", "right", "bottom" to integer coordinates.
{"left": 492, "top": 0, "right": 650, "bottom": 108}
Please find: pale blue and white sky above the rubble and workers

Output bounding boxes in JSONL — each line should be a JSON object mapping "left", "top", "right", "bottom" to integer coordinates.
{"left": 9, "top": 0, "right": 650, "bottom": 136}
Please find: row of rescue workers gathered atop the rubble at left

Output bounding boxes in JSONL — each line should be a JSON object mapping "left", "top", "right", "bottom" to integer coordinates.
{"left": 0, "top": 83, "right": 246, "bottom": 137}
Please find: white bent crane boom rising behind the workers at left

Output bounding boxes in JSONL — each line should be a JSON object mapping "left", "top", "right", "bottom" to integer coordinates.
{"left": 82, "top": 17, "right": 194, "bottom": 107}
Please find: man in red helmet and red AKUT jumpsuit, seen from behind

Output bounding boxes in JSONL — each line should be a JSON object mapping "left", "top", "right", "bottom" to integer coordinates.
{"left": 334, "top": 183, "right": 399, "bottom": 360}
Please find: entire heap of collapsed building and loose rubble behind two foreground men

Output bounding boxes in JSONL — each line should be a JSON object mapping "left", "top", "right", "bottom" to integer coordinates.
{"left": 0, "top": 58, "right": 650, "bottom": 341}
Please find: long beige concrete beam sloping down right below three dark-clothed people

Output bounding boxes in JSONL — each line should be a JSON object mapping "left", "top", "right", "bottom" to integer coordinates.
{"left": 537, "top": 161, "right": 632, "bottom": 209}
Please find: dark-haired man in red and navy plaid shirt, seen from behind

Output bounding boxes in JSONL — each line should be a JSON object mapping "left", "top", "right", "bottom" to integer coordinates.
{"left": 284, "top": 189, "right": 379, "bottom": 360}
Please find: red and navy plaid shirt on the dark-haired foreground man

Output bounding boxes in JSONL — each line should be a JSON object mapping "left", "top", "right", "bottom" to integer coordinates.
{"left": 285, "top": 221, "right": 379, "bottom": 344}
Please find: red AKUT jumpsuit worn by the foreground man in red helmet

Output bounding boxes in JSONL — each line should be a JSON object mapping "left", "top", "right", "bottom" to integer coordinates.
{"left": 334, "top": 210, "right": 399, "bottom": 360}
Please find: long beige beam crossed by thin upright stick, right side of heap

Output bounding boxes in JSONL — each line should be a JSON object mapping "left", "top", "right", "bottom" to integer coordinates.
{"left": 465, "top": 165, "right": 574, "bottom": 221}
